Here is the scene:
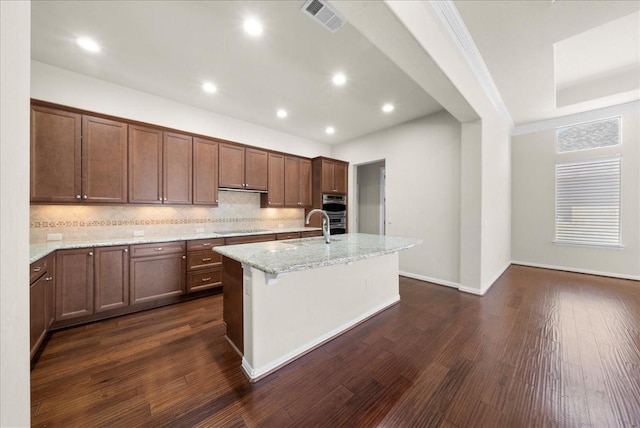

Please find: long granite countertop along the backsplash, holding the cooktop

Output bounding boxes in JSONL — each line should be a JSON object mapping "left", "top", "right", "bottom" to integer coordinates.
{"left": 29, "top": 227, "right": 321, "bottom": 263}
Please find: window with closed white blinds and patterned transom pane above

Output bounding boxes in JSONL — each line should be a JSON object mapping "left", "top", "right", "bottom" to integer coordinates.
{"left": 555, "top": 117, "right": 622, "bottom": 247}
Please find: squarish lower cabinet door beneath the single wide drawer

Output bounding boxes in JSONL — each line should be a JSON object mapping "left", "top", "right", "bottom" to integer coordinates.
{"left": 129, "top": 254, "right": 186, "bottom": 305}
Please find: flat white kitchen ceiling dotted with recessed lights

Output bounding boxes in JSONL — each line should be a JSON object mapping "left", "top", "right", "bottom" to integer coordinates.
{"left": 31, "top": 0, "right": 442, "bottom": 144}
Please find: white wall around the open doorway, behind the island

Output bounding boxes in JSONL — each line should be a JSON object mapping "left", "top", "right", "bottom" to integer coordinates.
{"left": 331, "top": 111, "right": 460, "bottom": 286}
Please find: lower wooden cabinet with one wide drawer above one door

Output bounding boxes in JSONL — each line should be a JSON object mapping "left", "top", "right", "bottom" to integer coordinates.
{"left": 129, "top": 241, "right": 187, "bottom": 305}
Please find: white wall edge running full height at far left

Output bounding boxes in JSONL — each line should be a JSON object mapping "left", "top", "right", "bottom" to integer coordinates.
{"left": 0, "top": 1, "right": 31, "bottom": 427}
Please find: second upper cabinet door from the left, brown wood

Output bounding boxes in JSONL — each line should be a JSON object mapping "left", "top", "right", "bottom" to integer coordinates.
{"left": 82, "top": 116, "right": 127, "bottom": 203}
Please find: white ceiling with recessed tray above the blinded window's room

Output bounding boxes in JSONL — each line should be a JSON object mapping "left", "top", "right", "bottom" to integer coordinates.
{"left": 455, "top": 0, "right": 640, "bottom": 126}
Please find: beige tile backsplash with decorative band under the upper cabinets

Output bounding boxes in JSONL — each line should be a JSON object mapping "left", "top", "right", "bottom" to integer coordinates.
{"left": 30, "top": 191, "right": 304, "bottom": 244}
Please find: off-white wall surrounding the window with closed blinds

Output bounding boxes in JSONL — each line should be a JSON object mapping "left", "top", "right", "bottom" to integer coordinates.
{"left": 512, "top": 108, "right": 640, "bottom": 279}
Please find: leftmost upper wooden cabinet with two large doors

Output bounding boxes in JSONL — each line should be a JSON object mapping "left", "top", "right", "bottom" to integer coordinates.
{"left": 31, "top": 106, "right": 127, "bottom": 203}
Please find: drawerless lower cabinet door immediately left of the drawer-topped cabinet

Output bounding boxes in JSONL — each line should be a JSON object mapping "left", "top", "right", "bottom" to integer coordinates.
{"left": 94, "top": 245, "right": 129, "bottom": 312}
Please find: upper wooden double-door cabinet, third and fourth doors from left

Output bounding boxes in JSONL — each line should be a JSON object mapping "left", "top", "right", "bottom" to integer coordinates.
{"left": 129, "top": 125, "right": 193, "bottom": 204}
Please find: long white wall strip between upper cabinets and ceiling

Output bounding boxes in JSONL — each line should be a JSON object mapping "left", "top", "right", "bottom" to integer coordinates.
{"left": 31, "top": 61, "right": 331, "bottom": 157}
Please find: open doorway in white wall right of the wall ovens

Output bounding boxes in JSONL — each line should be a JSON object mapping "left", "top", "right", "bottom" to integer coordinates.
{"left": 356, "top": 160, "right": 386, "bottom": 235}
